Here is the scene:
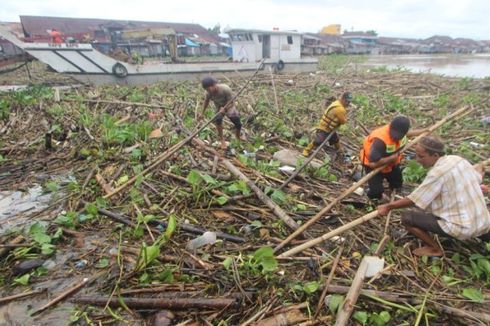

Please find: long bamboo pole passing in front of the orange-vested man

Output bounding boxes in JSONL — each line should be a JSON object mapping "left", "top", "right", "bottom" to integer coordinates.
{"left": 274, "top": 107, "right": 474, "bottom": 252}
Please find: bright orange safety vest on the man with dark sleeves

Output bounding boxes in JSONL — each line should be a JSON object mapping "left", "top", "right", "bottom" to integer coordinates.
{"left": 360, "top": 124, "right": 407, "bottom": 173}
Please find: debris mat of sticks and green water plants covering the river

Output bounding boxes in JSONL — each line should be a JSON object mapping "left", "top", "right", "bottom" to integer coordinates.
{"left": 0, "top": 57, "right": 490, "bottom": 325}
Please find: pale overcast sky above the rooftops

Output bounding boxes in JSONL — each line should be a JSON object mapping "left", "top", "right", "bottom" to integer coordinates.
{"left": 0, "top": 0, "right": 490, "bottom": 40}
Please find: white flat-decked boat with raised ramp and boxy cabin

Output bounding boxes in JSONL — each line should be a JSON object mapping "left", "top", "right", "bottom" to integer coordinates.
{"left": 0, "top": 26, "right": 317, "bottom": 85}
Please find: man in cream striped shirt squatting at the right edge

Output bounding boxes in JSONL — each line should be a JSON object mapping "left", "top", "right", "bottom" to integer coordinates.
{"left": 378, "top": 137, "right": 490, "bottom": 257}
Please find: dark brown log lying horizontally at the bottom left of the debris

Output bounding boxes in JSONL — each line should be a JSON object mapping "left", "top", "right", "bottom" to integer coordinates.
{"left": 73, "top": 296, "right": 238, "bottom": 310}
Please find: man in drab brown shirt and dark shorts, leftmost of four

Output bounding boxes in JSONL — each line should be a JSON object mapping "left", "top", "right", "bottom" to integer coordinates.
{"left": 199, "top": 77, "right": 246, "bottom": 149}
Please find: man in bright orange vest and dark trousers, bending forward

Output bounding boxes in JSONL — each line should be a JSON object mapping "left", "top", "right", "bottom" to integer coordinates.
{"left": 360, "top": 116, "right": 425, "bottom": 199}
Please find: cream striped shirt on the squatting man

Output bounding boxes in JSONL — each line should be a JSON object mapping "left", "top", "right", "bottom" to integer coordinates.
{"left": 408, "top": 155, "right": 490, "bottom": 240}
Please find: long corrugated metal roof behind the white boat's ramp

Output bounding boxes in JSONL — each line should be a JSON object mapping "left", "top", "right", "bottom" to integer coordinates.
{"left": 20, "top": 16, "right": 219, "bottom": 43}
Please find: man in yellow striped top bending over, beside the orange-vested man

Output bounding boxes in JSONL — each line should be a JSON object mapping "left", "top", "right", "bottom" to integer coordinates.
{"left": 303, "top": 92, "right": 352, "bottom": 157}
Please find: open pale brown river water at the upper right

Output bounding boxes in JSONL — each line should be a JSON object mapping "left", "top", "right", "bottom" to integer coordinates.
{"left": 362, "top": 53, "right": 490, "bottom": 78}
